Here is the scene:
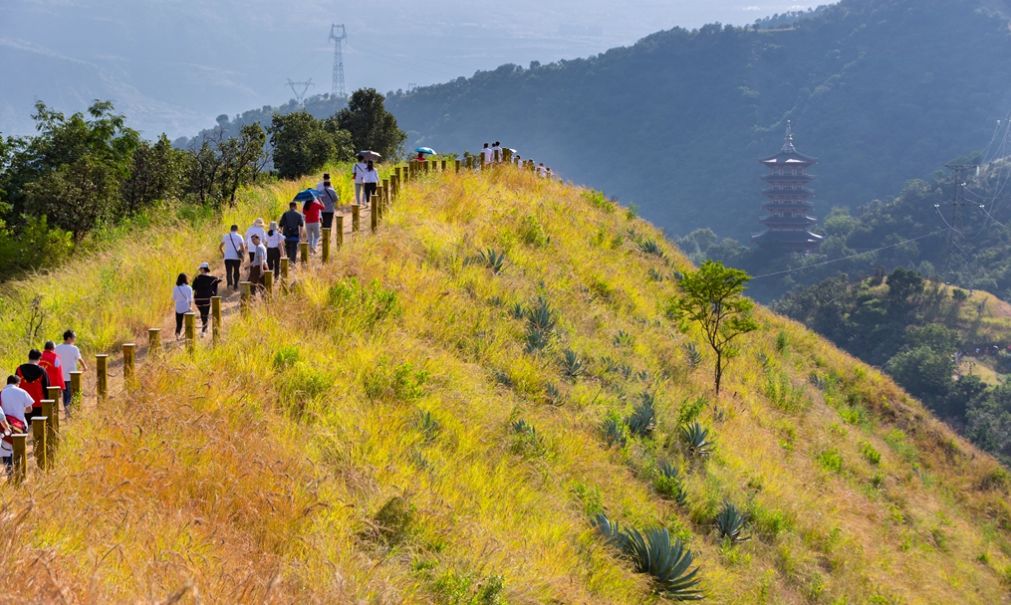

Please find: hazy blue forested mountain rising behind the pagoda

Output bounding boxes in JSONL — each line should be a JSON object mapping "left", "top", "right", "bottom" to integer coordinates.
{"left": 389, "top": 0, "right": 1011, "bottom": 239}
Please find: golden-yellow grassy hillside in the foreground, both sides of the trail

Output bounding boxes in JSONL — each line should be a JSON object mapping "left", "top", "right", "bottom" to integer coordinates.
{"left": 0, "top": 169, "right": 1011, "bottom": 604}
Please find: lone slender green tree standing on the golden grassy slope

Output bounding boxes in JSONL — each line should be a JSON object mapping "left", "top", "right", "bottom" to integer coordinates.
{"left": 668, "top": 261, "right": 758, "bottom": 396}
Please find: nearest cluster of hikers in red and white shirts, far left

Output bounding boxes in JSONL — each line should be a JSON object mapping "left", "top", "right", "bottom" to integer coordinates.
{"left": 0, "top": 330, "right": 88, "bottom": 474}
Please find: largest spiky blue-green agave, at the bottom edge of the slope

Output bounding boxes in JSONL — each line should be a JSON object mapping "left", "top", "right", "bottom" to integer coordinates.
{"left": 593, "top": 513, "right": 705, "bottom": 601}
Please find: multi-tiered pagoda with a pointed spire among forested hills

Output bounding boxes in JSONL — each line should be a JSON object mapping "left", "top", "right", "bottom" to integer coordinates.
{"left": 752, "top": 121, "right": 822, "bottom": 252}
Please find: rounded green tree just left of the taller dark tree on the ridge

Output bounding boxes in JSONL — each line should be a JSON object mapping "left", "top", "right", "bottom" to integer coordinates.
{"left": 270, "top": 111, "right": 338, "bottom": 178}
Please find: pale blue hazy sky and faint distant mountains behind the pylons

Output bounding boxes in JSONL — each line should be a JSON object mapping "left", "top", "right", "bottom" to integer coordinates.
{"left": 0, "top": 0, "right": 824, "bottom": 137}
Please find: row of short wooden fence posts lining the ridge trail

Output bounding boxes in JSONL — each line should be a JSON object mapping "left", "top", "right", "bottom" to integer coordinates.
{"left": 5, "top": 155, "right": 535, "bottom": 484}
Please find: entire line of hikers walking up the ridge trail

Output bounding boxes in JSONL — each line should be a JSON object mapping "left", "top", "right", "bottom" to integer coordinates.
{"left": 0, "top": 147, "right": 553, "bottom": 479}
